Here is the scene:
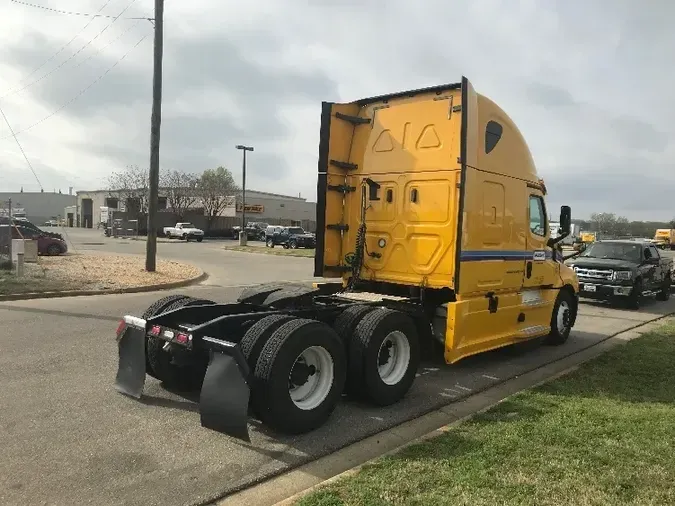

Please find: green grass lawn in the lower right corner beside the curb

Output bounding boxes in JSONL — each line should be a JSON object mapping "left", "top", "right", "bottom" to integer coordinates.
{"left": 296, "top": 323, "right": 675, "bottom": 506}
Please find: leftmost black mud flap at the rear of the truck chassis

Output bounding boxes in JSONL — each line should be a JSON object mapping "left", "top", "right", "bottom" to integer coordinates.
{"left": 115, "top": 323, "right": 145, "bottom": 399}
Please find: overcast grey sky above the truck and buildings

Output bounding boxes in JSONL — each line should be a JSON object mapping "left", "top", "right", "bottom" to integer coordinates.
{"left": 0, "top": 0, "right": 675, "bottom": 220}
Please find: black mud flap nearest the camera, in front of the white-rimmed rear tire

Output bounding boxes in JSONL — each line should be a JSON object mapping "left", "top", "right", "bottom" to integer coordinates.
{"left": 199, "top": 349, "right": 251, "bottom": 442}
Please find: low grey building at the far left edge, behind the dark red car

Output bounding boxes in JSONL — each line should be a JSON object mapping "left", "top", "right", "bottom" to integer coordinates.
{"left": 0, "top": 188, "right": 77, "bottom": 226}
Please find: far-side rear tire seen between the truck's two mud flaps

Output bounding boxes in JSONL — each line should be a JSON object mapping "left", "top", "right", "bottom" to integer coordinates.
{"left": 146, "top": 297, "right": 215, "bottom": 389}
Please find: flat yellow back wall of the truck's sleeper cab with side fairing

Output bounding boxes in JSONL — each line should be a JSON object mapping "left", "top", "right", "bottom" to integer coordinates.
{"left": 315, "top": 85, "right": 462, "bottom": 287}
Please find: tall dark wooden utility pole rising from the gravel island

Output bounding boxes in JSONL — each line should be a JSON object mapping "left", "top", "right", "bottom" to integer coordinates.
{"left": 145, "top": 0, "right": 164, "bottom": 272}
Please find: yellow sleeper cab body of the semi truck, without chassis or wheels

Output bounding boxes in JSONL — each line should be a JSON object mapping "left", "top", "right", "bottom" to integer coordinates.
{"left": 314, "top": 78, "right": 578, "bottom": 363}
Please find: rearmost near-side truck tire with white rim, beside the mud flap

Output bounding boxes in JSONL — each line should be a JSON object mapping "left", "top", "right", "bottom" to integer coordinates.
{"left": 251, "top": 318, "right": 347, "bottom": 434}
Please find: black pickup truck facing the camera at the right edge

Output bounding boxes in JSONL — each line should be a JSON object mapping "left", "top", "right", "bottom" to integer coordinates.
{"left": 565, "top": 240, "right": 673, "bottom": 309}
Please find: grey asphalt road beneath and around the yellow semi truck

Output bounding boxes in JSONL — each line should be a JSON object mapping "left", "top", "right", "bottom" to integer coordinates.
{"left": 0, "top": 239, "right": 675, "bottom": 506}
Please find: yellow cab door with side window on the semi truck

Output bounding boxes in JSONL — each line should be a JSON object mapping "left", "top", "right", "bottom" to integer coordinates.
{"left": 523, "top": 192, "right": 560, "bottom": 289}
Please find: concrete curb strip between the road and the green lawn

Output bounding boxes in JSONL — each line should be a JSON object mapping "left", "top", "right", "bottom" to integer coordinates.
{"left": 210, "top": 313, "right": 675, "bottom": 506}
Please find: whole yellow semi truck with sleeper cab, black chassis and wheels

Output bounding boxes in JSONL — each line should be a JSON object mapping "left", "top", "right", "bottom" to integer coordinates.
{"left": 116, "top": 78, "right": 579, "bottom": 439}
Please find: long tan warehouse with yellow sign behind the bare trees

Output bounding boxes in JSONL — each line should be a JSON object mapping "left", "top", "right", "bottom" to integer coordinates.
{"left": 70, "top": 190, "right": 316, "bottom": 228}
